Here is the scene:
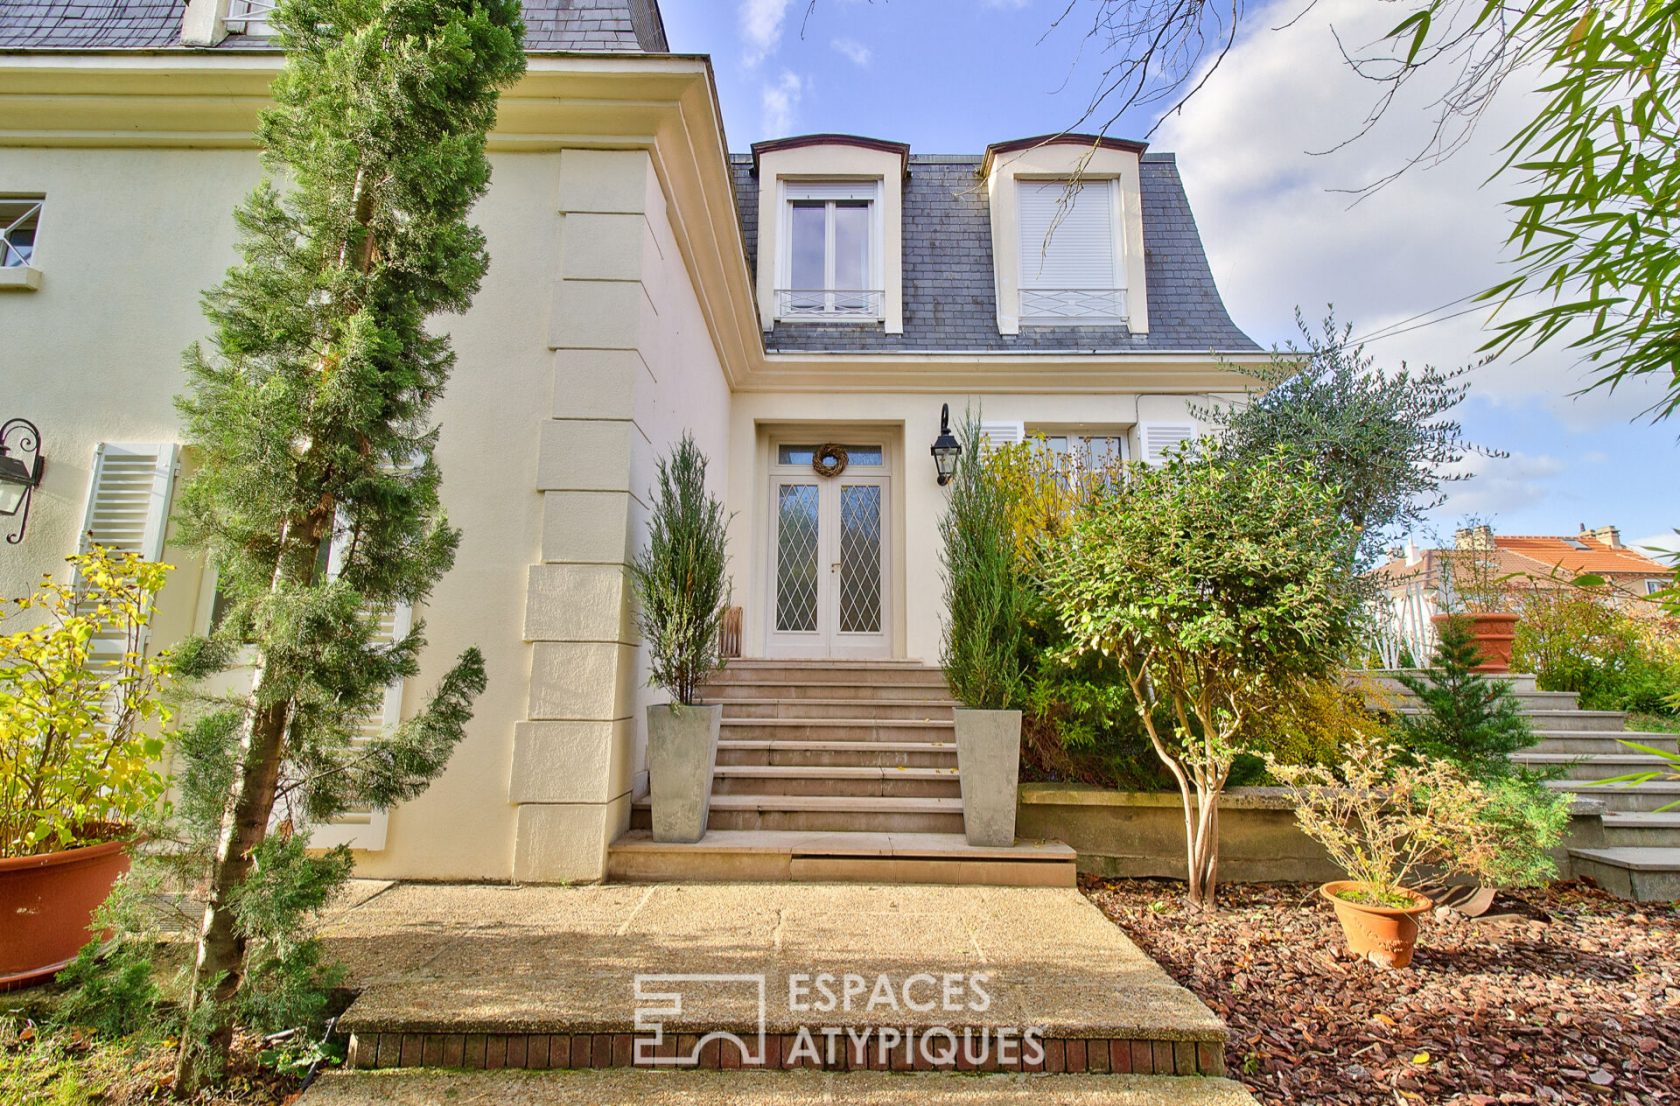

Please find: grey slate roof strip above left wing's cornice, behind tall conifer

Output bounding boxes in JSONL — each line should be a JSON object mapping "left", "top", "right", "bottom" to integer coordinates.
{"left": 0, "top": 0, "right": 669, "bottom": 54}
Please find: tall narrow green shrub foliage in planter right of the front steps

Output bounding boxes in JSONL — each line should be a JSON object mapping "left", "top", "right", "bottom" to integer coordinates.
{"left": 939, "top": 413, "right": 1030, "bottom": 711}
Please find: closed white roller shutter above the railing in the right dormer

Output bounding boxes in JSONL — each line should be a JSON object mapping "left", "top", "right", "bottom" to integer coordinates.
{"left": 1016, "top": 180, "right": 1119, "bottom": 289}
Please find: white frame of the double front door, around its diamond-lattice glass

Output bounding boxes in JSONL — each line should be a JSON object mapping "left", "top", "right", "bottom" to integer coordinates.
{"left": 763, "top": 430, "right": 894, "bottom": 659}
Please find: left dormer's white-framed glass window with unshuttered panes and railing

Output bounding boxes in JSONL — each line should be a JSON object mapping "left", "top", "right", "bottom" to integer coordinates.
{"left": 776, "top": 182, "right": 884, "bottom": 321}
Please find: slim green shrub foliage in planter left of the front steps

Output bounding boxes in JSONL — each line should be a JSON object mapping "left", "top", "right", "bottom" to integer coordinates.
{"left": 630, "top": 434, "right": 729, "bottom": 704}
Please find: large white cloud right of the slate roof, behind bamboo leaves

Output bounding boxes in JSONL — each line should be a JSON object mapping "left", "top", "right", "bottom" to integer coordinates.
{"left": 1154, "top": 0, "right": 1660, "bottom": 430}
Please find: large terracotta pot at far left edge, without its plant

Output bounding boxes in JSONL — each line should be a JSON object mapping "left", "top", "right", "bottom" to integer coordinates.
{"left": 0, "top": 840, "right": 129, "bottom": 990}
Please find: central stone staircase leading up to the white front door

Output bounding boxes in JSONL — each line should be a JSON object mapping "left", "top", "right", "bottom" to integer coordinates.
{"left": 608, "top": 661, "right": 1075, "bottom": 886}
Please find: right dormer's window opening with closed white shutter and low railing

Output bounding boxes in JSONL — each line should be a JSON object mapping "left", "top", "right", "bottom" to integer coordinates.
{"left": 1015, "top": 180, "right": 1126, "bottom": 326}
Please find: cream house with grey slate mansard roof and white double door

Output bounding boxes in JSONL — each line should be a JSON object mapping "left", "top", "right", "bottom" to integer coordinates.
{"left": 0, "top": 0, "right": 1263, "bottom": 881}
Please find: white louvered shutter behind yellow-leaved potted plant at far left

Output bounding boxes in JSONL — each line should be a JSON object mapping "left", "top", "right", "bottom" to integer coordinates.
{"left": 77, "top": 442, "right": 180, "bottom": 661}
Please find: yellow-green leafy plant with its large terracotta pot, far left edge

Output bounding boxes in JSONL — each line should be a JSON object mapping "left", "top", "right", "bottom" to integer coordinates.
{"left": 0, "top": 546, "right": 170, "bottom": 990}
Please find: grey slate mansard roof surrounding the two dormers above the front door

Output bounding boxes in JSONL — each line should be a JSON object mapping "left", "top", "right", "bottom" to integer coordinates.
{"left": 729, "top": 153, "right": 1260, "bottom": 353}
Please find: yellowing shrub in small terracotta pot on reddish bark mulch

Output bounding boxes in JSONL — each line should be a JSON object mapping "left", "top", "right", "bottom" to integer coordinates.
{"left": 1270, "top": 733, "right": 1509, "bottom": 968}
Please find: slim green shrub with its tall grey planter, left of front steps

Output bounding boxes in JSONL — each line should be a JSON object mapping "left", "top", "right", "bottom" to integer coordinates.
{"left": 630, "top": 434, "right": 729, "bottom": 844}
